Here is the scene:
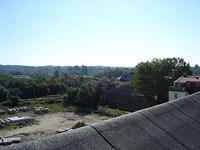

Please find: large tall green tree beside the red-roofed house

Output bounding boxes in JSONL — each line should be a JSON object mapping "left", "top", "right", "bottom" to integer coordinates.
{"left": 133, "top": 58, "right": 192, "bottom": 106}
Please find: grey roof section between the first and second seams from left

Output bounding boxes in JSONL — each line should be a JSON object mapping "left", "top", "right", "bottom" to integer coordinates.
{"left": 92, "top": 113, "right": 185, "bottom": 150}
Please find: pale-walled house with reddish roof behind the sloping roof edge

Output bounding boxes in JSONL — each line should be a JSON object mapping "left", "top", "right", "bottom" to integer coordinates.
{"left": 169, "top": 76, "right": 200, "bottom": 101}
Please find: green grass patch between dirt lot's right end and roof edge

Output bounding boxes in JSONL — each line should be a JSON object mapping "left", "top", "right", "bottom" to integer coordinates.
{"left": 95, "top": 106, "right": 128, "bottom": 117}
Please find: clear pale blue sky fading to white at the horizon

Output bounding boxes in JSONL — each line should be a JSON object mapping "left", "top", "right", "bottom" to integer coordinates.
{"left": 0, "top": 0, "right": 200, "bottom": 66}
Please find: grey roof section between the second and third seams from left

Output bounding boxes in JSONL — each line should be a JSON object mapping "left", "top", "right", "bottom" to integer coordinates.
{"left": 140, "top": 101, "right": 200, "bottom": 150}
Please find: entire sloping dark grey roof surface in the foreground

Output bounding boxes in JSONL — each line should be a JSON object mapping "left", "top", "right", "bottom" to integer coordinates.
{"left": 0, "top": 92, "right": 200, "bottom": 150}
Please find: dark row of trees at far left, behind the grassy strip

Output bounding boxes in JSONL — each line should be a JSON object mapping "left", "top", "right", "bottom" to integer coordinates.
{"left": 0, "top": 74, "right": 67, "bottom": 101}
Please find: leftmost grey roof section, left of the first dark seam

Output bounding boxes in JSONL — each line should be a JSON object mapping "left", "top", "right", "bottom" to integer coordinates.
{"left": 0, "top": 127, "right": 113, "bottom": 150}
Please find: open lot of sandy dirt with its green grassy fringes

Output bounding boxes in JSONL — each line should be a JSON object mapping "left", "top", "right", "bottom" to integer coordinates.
{"left": 0, "top": 96, "right": 128, "bottom": 142}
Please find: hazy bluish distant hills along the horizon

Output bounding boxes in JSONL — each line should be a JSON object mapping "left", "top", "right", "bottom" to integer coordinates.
{"left": 0, "top": 65, "right": 133, "bottom": 78}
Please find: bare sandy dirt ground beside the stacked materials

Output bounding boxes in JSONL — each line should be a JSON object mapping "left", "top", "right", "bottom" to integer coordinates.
{"left": 0, "top": 112, "right": 108, "bottom": 142}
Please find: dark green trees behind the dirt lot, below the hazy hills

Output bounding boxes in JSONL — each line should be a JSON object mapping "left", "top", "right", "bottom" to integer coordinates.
{"left": 0, "top": 74, "right": 118, "bottom": 108}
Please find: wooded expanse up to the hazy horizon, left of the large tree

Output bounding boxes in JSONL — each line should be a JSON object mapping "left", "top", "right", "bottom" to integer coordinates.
{"left": 0, "top": 65, "right": 131, "bottom": 109}
